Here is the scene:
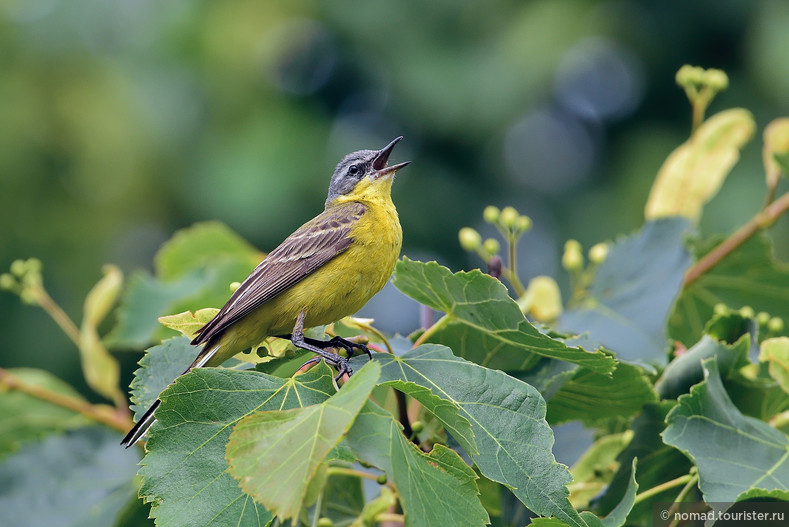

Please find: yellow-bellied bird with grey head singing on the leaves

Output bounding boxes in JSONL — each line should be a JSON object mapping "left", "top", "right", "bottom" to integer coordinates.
{"left": 121, "top": 136, "right": 410, "bottom": 448}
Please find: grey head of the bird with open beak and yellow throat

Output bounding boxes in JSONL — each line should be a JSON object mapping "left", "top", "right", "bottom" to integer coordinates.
{"left": 326, "top": 136, "right": 410, "bottom": 205}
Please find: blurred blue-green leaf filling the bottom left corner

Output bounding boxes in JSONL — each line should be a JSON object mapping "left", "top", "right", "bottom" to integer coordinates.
{"left": 0, "top": 427, "right": 139, "bottom": 527}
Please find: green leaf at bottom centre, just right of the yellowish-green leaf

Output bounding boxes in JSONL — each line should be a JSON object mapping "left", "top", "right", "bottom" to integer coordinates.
{"left": 348, "top": 402, "right": 489, "bottom": 527}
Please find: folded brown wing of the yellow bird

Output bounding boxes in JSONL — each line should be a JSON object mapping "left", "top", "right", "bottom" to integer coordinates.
{"left": 192, "top": 203, "right": 365, "bottom": 345}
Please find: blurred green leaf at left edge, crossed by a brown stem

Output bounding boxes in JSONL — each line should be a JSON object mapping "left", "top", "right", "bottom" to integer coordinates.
{"left": 0, "top": 368, "right": 91, "bottom": 458}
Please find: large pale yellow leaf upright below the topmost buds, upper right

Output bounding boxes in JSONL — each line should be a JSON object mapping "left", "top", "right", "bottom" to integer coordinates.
{"left": 645, "top": 108, "right": 756, "bottom": 221}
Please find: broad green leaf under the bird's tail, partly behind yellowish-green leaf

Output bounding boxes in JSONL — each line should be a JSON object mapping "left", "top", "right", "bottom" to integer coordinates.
{"left": 139, "top": 364, "right": 335, "bottom": 527}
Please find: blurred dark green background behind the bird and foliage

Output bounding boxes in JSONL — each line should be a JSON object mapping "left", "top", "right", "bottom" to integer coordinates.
{"left": 0, "top": 0, "right": 789, "bottom": 404}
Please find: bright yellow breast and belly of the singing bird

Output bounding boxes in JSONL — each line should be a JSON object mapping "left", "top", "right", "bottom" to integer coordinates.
{"left": 211, "top": 200, "right": 402, "bottom": 363}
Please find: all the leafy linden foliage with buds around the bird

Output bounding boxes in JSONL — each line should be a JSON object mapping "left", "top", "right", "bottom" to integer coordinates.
{"left": 0, "top": 69, "right": 789, "bottom": 527}
